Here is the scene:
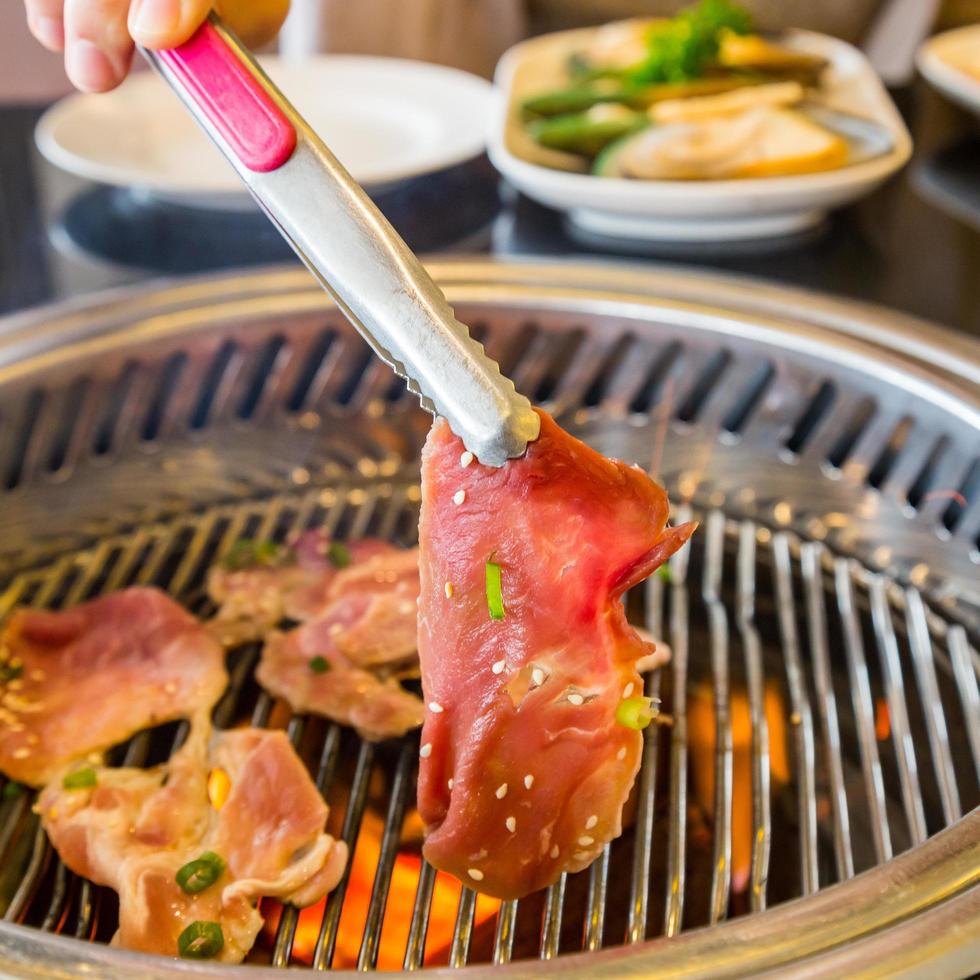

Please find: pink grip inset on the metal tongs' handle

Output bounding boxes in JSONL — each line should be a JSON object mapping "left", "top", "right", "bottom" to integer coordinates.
{"left": 157, "top": 20, "right": 296, "bottom": 173}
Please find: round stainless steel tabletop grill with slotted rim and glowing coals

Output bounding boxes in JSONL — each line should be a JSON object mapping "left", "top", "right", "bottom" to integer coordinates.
{"left": 0, "top": 260, "right": 980, "bottom": 978}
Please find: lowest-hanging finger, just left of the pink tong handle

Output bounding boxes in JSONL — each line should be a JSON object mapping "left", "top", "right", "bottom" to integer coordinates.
{"left": 65, "top": 0, "right": 133, "bottom": 92}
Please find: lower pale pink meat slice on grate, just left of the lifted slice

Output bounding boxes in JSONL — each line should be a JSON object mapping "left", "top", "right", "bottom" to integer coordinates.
{"left": 255, "top": 620, "right": 424, "bottom": 741}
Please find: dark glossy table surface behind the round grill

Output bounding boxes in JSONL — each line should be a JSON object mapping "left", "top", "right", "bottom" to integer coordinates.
{"left": 0, "top": 81, "right": 980, "bottom": 336}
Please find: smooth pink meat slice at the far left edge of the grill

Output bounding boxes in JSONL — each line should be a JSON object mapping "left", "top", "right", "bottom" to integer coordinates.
{"left": 0, "top": 588, "right": 228, "bottom": 786}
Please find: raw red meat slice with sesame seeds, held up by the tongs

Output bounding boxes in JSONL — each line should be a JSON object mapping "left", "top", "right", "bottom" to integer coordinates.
{"left": 419, "top": 413, "right": 694, "bottom": 899}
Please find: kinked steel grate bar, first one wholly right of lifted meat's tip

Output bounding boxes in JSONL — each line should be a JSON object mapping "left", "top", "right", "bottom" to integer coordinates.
{"left": 701, "top": 510, "right": 733, "bottom": 925}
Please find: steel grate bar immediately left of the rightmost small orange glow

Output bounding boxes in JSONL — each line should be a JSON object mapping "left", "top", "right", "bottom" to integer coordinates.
{"left": 834, "top": 558, "right": 892, "bottom": 864}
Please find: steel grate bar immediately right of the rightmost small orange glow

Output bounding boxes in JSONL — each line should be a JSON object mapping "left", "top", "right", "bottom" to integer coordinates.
{"left": 871, "top": 575, "right": 928, "bottom": 845}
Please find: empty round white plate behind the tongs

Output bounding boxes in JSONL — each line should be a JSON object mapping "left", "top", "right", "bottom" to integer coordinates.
{"left": 35, "top": 55, "right": 493, "bottom": 207}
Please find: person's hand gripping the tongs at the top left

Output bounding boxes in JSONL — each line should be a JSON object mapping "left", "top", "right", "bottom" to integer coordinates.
{"left": 24, "top": 0, "right": 289, "bottom": 92}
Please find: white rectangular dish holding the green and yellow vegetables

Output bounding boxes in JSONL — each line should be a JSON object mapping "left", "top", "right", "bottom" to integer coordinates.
{"left": 488, "top": 29, "right": 912, "bottom": 241}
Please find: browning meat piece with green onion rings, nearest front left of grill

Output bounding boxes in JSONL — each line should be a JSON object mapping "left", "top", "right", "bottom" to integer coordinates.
{"left": 37, "top": 725, "right": 347, "bottom": 963}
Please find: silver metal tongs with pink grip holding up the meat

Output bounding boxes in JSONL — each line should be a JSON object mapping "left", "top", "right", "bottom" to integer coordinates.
{"left": 142, "top": 15, "right": 540, "bottom": 466}
